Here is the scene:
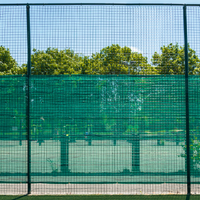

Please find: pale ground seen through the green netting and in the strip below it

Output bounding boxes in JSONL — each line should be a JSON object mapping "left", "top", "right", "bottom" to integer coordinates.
{"left": 0, "top": 140, "right": 200, "bottom": 195}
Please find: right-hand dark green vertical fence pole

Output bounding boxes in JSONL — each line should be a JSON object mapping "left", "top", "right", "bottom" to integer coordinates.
{"left": 183, "top": 5, "right": 191, "bottom": 195}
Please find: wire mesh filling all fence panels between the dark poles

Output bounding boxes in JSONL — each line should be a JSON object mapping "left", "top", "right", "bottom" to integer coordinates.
{"left": 0, "top": 5, "right": 200, "bottom": 194}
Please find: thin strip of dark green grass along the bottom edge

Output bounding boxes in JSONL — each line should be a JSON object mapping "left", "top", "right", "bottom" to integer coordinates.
{"left": 0, "top": 195, "right": 200, "bottom": 200}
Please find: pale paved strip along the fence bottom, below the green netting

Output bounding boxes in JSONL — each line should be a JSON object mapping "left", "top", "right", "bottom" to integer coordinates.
{"left": 0, "top": 184, "right": 200, "bottom": 195}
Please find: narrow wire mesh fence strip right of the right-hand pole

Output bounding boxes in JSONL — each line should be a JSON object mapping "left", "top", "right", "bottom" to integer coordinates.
{"left": 187, "top": 6, "right": 200, "bottom": 194}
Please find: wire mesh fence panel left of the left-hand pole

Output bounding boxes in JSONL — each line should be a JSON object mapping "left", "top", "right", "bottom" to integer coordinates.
{"left": 0, "top": 6, "right": 28, "bottom": 194}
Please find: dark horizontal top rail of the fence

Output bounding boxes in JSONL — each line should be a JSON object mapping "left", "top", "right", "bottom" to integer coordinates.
{"left": 0, "top": 3, "right": 200, "bottom": 6}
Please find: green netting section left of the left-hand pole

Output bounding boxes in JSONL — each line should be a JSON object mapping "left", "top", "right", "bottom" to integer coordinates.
{"left": 0, "top": 76, "right": 27, "bottom": 183}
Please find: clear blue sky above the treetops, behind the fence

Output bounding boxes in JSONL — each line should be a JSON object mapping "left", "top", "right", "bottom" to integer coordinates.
{"left": 0, "top": 0, "right": 200, "bottom": 65}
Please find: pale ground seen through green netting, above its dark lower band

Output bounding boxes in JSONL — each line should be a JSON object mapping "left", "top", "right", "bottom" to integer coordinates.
{"left": 0, "top": 140, "right": 185, "bottom": 176}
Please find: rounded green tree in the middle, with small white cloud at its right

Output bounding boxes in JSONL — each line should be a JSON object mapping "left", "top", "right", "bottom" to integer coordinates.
{"left": 91, "top": 44, "right": 150, "bottom": 74}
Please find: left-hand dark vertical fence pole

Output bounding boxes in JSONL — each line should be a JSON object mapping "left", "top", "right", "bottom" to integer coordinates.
{"left": 26, "top": 4, "right": 31, "bottom": 194}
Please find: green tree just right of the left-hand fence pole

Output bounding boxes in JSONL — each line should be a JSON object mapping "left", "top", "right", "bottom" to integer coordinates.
{"left": 21, "top": 48, "right": 88, "bottom": 75}
